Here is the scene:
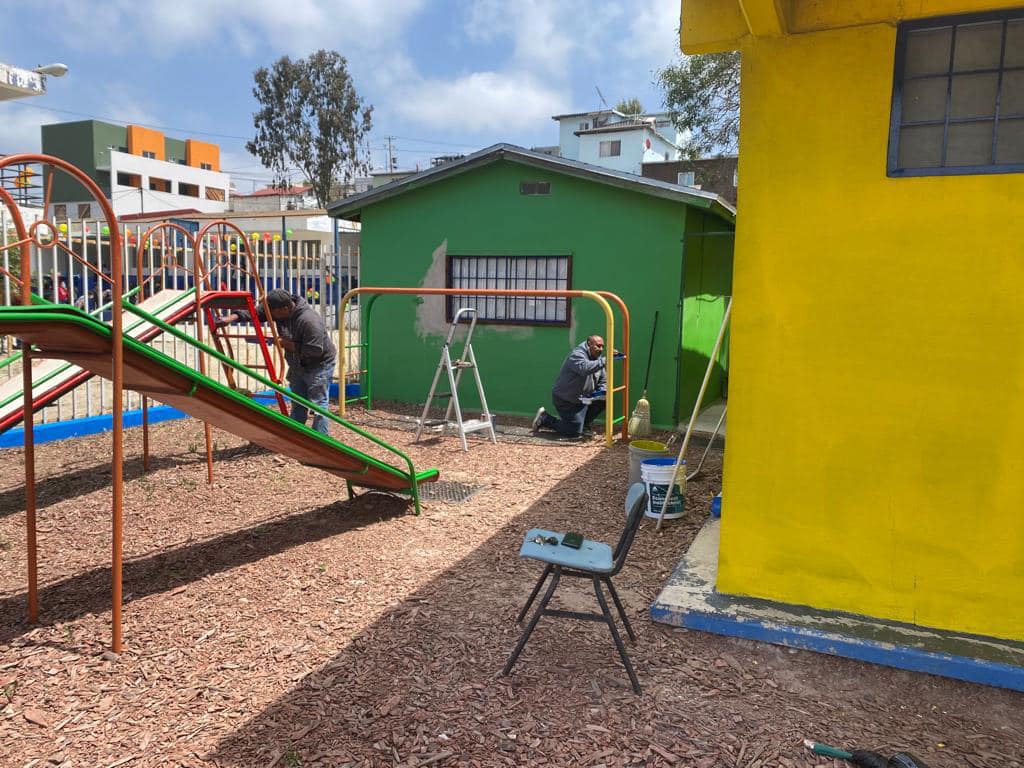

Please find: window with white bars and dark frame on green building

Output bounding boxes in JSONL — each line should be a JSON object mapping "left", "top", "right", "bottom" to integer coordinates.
{"left": 447, "top": 256, "right": 571, "bottom": 326}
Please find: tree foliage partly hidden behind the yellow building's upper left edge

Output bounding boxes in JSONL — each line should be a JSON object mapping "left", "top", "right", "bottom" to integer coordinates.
{"left": 657, "top": 51, "right": 739, "bottom": 159}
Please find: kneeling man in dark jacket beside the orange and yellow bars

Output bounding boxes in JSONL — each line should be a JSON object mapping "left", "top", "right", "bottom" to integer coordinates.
{"left": 534, "top": 336, "right": 605, "bottom": 438}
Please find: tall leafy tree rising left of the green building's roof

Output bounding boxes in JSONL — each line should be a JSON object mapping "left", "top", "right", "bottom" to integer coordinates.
{"left": 246, "top": 50, "right": 374, "bottom": 207}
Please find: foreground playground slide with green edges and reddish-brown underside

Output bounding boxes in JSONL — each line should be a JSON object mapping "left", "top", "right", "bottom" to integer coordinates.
{"left": 0, "top": 304, "right": 438, "bottom": 493}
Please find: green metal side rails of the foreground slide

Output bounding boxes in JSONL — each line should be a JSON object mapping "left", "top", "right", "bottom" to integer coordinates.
{"left": 0, "top": 301, "right": 438, "bottom": 514}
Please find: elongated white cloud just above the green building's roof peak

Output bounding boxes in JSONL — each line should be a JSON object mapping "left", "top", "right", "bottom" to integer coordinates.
{"left": 395, "top": 72, "right": 566, "bottom": 133}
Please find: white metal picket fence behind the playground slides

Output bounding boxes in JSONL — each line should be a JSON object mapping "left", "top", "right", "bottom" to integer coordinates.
{"left": 0, "top": 217, "right": 360, "bottom": 430}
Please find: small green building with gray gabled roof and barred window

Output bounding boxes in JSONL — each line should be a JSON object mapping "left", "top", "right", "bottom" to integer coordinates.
{"left": 328, "top": 144, "right": 735, "bottom": 434}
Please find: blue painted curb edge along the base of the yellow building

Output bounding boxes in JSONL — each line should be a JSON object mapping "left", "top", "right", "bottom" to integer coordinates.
{"left": 650, "top": 604, "right": 1024, "bottom": 691}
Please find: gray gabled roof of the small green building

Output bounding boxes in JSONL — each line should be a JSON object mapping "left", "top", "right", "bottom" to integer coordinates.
{"left": 327, "top": 143, "right": 736, "bottom": 223}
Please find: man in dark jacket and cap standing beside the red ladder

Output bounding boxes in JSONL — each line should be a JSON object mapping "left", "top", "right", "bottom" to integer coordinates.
{"left": 217, "top": 288, "right": 338, "bottom": 434}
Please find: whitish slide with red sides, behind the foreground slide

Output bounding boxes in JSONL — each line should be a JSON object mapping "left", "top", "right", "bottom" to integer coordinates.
{"left": 0, "top": 288, "right": 196, "bottom": 432}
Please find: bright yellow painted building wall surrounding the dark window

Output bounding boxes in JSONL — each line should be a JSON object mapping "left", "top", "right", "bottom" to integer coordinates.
{"left": 718, "top": 24, "right": 1024, "bottom": 640}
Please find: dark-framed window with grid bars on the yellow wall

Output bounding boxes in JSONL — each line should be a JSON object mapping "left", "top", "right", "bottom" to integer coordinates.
{"left": 888, "top": 9, "right": 1024, "bottom": 176}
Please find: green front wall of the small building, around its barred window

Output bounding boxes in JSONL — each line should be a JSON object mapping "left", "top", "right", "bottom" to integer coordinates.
{"left": 361, "top": 161, "right": 724, "bottom": 426}
